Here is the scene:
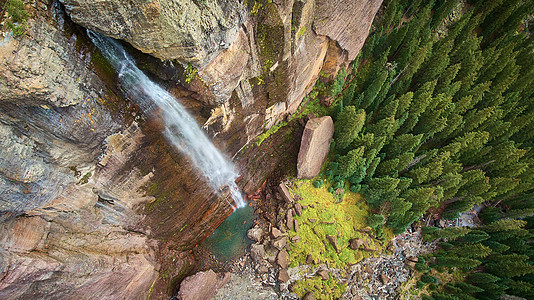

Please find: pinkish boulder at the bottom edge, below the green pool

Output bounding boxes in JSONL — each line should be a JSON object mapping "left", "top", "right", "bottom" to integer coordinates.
{"left": 177, "top": 270, "right": 230, "bottom": 300}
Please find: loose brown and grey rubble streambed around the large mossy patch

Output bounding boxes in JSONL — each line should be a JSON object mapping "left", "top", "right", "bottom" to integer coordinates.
{"left": 178, "top": 179, "right": 434, "bottom": 299}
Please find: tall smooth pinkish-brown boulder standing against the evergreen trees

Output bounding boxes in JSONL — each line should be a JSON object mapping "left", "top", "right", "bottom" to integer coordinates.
{"left": 297, "top": 116, "right": 334, "bottom": 178}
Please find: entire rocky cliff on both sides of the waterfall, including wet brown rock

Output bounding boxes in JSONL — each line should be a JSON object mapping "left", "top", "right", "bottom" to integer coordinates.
{"left": 0, "top": 0, "right": 381, "bottom": 299}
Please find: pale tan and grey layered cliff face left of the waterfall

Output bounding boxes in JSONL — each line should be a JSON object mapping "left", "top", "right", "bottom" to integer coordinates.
{"left": 0, "top": 1, "right": 157, "bottom": 299}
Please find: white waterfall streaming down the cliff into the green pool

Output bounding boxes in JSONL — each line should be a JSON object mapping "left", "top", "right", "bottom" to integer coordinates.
{"left": 88, "top": 30, "right": 245, "bottom": 208}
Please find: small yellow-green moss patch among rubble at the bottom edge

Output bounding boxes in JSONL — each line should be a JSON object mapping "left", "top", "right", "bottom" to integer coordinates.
{"left": 294, "top": 277, "right": 347, "bottom": 300}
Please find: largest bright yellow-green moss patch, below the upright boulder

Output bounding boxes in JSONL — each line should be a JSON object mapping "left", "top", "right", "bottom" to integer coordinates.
{"left": 289, "top": 179, "right": 383, "bottom": 268}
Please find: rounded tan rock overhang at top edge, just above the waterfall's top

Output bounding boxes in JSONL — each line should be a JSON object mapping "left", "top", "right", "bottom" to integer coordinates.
{"left": 61, "top": 0, "right": 245, "bottom": 65}
